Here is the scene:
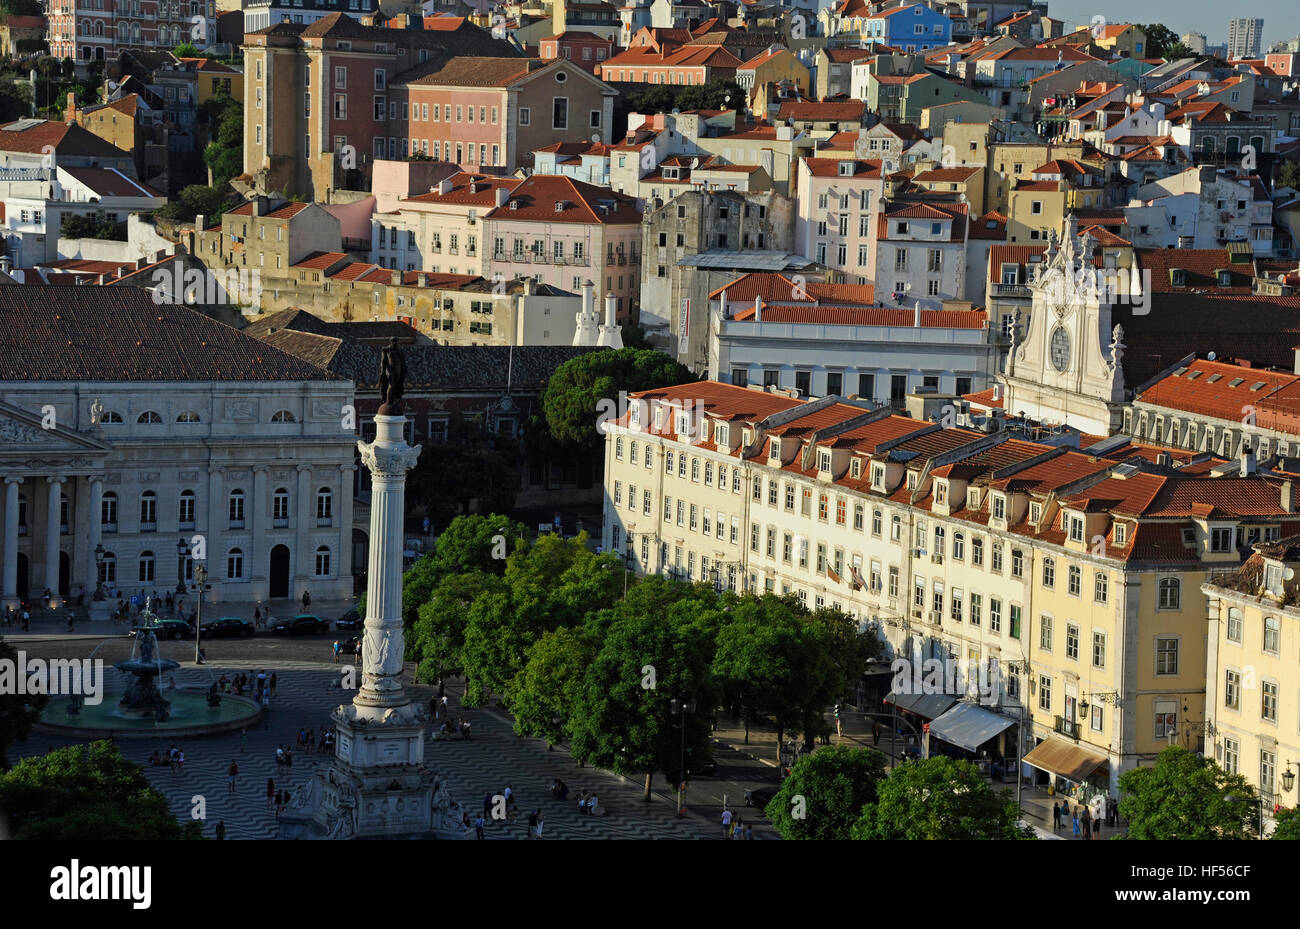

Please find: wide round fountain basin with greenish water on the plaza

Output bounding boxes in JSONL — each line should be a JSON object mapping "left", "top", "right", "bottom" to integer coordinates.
{"left": 35, "top": 687, "right": 267, "bottom": 739}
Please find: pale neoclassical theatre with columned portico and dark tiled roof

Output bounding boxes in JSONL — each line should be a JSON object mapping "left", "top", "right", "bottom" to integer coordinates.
{"left": 0, "top": 286, "right": 356, "bottom": 605}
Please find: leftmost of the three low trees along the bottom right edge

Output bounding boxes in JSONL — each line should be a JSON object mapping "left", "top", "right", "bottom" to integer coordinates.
{"left": 764, "top": 746, "right": 885, "bottom": 841}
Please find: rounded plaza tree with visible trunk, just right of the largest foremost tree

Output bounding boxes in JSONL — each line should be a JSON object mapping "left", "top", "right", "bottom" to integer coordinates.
{"left": 714, "top": 594, "right": 842, "bottom": 763}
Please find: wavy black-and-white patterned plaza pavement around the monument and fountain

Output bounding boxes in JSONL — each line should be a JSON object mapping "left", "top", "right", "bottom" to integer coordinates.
{"left": 22, "top": 647, "right": 775, "bottom": 839}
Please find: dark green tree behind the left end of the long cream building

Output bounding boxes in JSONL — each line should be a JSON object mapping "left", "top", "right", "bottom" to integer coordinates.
{"left": 542, "top": 348, "right": 697, "bottom": 452}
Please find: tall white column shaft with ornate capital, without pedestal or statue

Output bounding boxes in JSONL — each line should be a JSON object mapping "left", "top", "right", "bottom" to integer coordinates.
{"left": 355, "top": 413, "right": 420, "bottom": 707}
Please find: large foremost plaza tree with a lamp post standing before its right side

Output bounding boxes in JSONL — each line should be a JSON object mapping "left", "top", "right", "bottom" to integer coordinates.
{"left": 569, "top": 589, "right": 720, "bottom": 800}
